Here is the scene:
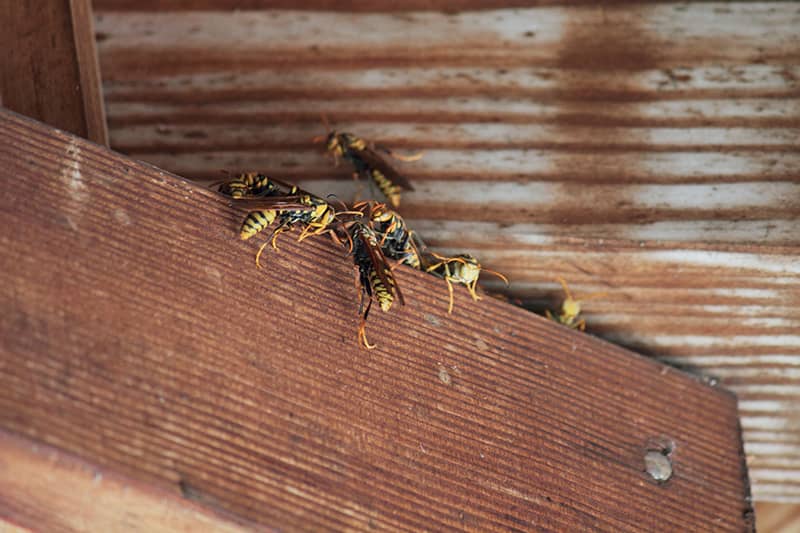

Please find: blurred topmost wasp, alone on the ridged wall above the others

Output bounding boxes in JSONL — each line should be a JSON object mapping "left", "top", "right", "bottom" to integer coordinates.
{"left": 315, "top": 117, "right": 422, "bottom": 208}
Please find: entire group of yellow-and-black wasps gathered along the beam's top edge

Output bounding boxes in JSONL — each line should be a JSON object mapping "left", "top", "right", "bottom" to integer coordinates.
{"left": 219, "top": 126, "right": 600, "bottom": 349}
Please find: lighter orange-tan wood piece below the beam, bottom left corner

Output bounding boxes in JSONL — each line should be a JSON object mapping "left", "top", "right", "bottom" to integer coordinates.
{"left": 0, "top": 431, "right": 248, "bottom": 533}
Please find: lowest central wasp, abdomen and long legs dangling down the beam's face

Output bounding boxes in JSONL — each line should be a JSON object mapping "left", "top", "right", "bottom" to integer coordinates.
{"left": 350, "top": 222, "right": 405, "bottom": 350}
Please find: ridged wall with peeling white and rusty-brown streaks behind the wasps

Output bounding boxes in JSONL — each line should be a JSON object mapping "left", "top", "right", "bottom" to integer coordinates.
{"left": 95, "top": 0, "right": 800, "bottom": 501}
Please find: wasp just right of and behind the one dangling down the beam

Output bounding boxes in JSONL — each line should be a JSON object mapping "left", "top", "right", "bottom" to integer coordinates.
{"left": 353, "top": 202, "right": 424, "bottom": 270}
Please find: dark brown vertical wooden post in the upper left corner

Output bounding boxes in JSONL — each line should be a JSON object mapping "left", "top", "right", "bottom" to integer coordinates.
{"left": 0, "top": 0, "right": 108, "bottom": 145}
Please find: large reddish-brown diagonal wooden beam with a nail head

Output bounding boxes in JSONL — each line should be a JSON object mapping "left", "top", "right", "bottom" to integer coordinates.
{"left": 0, "top": 113, "right": 752, "bottom": 531}
